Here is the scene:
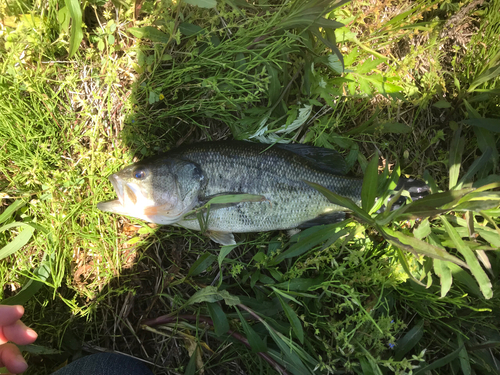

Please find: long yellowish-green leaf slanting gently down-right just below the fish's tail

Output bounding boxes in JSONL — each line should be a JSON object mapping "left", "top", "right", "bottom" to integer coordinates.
{"left": 378, "top": 226, "right": 468, "bottom": 268}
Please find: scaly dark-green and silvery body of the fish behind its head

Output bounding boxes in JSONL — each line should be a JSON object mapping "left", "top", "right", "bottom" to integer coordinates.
{"left": 172, "top": 141, "right": 362, "bottom": 233}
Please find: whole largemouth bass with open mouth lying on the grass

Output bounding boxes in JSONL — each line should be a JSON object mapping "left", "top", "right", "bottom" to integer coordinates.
{"left": 97, "top": 141, "right": 428, "bottom": 245}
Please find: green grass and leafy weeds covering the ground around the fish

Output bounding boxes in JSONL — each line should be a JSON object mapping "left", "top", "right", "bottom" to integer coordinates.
{"left": 0, "top": 0, "right": 500, "bottom": 374}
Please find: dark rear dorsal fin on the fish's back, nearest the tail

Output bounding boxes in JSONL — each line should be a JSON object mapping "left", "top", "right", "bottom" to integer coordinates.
{"left": 274, "top": 143, "right": 347, "bottom": 175}
